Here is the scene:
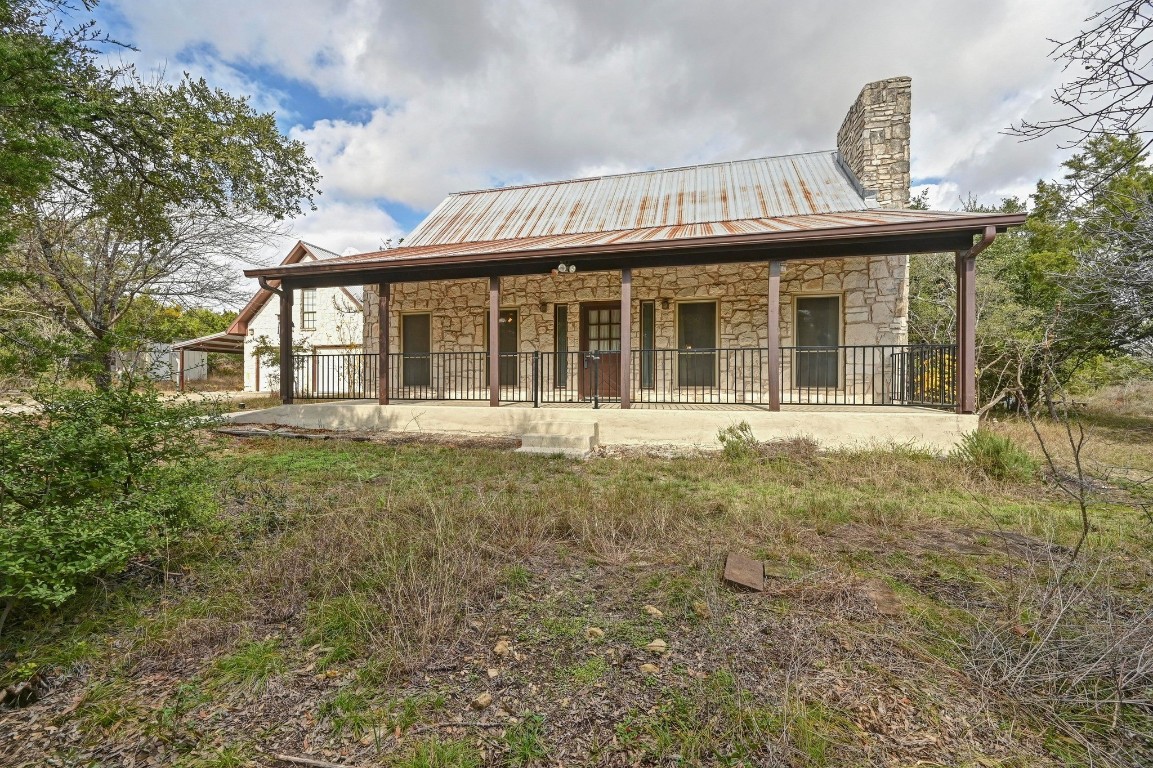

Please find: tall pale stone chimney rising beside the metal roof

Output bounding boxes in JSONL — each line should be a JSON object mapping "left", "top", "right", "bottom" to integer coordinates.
{"left": 837, "top": 77, "right": 913, "bottom": 208}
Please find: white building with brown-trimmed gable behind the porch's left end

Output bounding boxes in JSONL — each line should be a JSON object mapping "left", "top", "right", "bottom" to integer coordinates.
{"left": 174, "top": 241, "right": 364, "bottom": 397}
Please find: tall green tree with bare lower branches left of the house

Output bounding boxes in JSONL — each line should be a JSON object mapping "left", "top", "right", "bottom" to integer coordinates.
{"left": 0, "top": 0, "right": 319, "bottom": 386}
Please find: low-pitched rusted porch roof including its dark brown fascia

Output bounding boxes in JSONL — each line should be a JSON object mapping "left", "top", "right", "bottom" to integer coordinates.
{"left": 244, "top": 209, "right": 1025, "bottom": 287}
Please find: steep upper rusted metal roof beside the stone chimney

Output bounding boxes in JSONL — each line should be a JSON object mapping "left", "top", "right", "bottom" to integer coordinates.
{"left": 395, "top": 151, "right": 876, "bottom": 245}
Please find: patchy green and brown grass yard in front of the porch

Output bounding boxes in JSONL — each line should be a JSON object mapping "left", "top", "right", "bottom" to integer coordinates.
{"left": 0, "top": 414, "right": 1153, "bottom": 766}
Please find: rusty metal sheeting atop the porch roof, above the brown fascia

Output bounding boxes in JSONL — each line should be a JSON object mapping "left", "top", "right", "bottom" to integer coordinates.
{"left": 318, "top": 208, "right": 987, "bottom": 268}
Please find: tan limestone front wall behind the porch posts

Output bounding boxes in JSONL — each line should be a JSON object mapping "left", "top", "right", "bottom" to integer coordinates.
{"left": 364, "top": 257, "right": 907, "bottom": 401}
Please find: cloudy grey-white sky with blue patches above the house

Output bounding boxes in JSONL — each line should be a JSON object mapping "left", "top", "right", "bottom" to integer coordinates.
{"left": 97, "top": 0, "right": 1103, "bottom": 263}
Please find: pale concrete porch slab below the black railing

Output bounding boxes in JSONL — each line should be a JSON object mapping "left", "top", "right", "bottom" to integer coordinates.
{"left": 226, "top": 400, "right": 978, "bottom": 453}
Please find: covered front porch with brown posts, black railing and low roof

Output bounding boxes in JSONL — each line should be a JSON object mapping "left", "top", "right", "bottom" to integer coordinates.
{"left": 248, "top": 210, "right": 1023, "bottom": 414}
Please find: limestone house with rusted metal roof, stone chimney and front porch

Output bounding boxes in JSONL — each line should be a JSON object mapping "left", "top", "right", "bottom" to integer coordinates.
{"left": 236, "top": 77, "right": 1025, "bottom": 449}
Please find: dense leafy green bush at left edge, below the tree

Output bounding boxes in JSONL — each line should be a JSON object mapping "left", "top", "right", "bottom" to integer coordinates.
{"left": 0, "top": 384, "right": 206, "bottom": 631}
